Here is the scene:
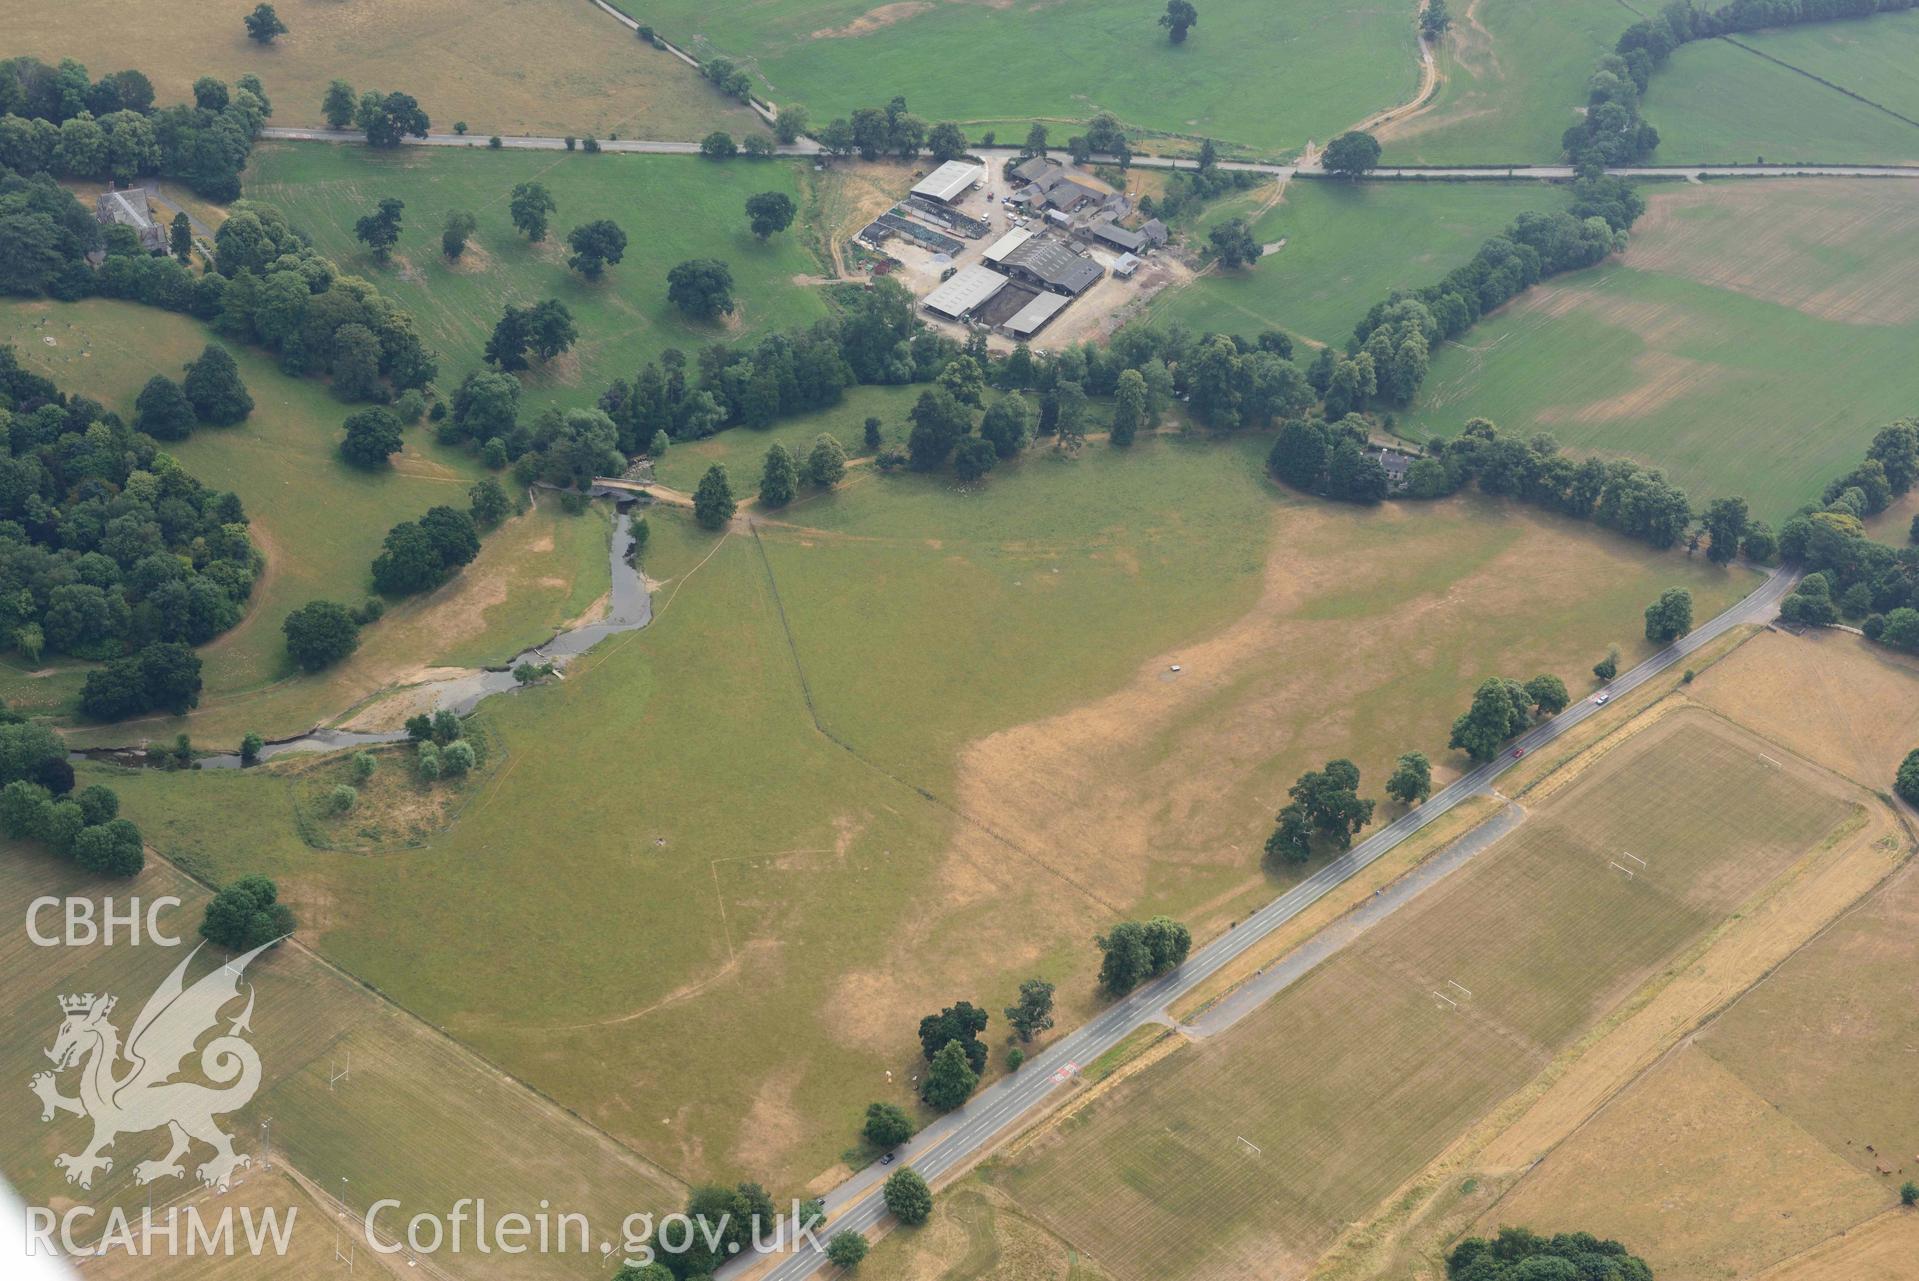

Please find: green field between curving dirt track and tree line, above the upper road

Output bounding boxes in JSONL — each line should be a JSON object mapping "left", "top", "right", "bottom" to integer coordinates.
{"left": 1380, "top": 0, "right": 1627, "bottom": 165}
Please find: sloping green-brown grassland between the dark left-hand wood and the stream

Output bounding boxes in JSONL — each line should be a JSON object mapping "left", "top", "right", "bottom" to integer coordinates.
{"left": 0, "top": 299, "right": 608, "bottom": 748}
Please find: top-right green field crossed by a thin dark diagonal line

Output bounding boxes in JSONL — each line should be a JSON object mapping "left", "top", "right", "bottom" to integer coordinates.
{"left": 1645, "top": 13, "right": 1919, "bottom": 165}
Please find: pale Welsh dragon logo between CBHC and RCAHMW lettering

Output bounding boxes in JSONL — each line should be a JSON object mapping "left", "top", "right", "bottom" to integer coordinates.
{"left": 31, "top": 943, "right": 272, "bottom": 1189}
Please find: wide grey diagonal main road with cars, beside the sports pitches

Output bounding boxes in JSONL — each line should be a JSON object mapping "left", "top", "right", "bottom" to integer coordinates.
{"left": 722, "top": 570, "right": 1798, "bottom": 1281}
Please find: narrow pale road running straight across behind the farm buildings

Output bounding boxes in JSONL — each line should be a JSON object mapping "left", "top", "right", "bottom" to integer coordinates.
{"left": 259, "top": 127, "right": 1919, "bottom": 182}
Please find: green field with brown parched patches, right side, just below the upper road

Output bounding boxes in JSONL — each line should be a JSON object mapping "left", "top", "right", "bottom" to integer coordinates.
{"left": 1399, "top": 180, "right": 1919, "bottom": 524}
